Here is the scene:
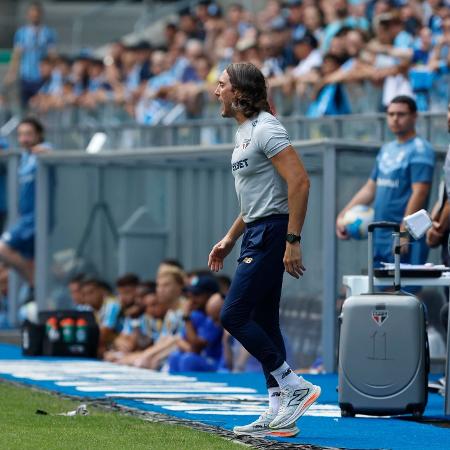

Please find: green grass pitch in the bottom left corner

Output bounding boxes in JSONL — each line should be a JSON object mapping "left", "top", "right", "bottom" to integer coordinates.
{"left": 0, "top": 380, "right": 245, "bottom": 450}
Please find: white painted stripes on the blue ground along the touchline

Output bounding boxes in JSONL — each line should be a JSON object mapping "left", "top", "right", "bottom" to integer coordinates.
{"left": 0, "top": 360, "right": 341, "bottom": 418}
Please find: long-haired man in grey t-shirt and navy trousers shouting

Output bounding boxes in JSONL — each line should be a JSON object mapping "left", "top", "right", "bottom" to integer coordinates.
{"left": 208, "top": 63, "right": 320, "bottom": 436}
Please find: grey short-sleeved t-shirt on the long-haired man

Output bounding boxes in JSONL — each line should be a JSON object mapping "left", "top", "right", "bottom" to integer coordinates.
{"left": 231, "top": 111, "right": 291, "bottom": 223}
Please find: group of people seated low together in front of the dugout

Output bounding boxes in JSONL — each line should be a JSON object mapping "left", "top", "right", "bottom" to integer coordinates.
{"left": 64, "top": 260, "right": 259, "bottom": 373}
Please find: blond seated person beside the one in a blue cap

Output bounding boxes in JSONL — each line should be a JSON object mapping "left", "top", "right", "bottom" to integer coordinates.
{"left": 129, "top": 266, "right": 185, "bottom": 370}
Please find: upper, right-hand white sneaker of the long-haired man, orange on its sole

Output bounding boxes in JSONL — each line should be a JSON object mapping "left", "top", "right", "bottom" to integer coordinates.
{"left": 269, "top": 381, "right": 321, "bottom": 430}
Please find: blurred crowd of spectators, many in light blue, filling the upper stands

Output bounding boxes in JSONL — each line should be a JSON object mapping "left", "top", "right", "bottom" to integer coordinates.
{"left": 4, "top": 0, "right": 450, "bottom": 121}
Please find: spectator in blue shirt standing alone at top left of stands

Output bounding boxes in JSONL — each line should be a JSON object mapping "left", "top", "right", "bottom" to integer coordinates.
{"left": 5, "top": 2, "right": 56, "bottom": 107}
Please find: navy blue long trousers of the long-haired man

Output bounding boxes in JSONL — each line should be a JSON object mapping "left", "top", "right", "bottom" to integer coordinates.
{"left": 221, "top": 214, "right": 288, "bottom": 387}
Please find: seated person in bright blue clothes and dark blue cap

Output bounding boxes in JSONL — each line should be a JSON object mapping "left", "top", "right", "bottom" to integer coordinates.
{"left": 169, "top": 276, "right": 223, "bottom": 373}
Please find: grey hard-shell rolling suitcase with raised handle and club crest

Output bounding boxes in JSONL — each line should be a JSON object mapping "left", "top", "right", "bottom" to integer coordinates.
{"left": 338, "top": 222, "right": 429, "bottom": 417}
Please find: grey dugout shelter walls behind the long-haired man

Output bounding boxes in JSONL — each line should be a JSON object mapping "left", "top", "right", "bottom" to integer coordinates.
{"left": 30, "top": 140, "right": 445, "bottom": 371}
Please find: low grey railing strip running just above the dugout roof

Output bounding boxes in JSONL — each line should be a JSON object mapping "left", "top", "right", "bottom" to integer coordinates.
{"left": 1, "top": 113, "right": 442, "bottom": 151}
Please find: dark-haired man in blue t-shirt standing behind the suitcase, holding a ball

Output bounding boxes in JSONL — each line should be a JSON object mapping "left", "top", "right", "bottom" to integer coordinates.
{"left": 336, "top": 95, "right": 435, "bottom": 267}
